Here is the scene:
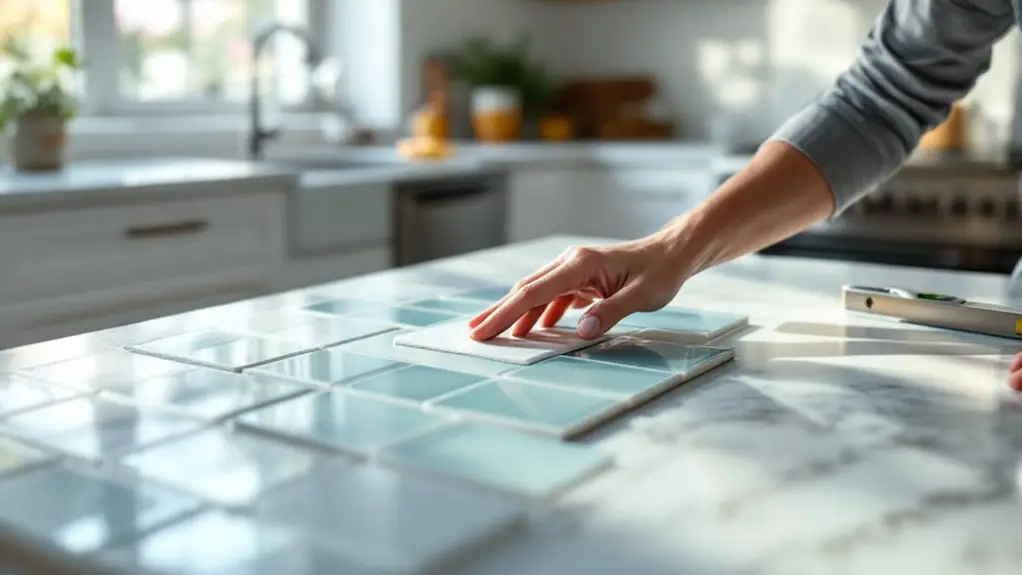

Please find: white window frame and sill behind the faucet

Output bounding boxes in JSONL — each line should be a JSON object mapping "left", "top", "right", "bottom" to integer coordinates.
{"left": 69, "top": 0, "right": 334, "bottom": 117}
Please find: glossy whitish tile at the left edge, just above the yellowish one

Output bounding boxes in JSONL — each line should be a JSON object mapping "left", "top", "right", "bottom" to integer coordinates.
{"left": 0, "top": 397, "right": 203, "bottom": 462}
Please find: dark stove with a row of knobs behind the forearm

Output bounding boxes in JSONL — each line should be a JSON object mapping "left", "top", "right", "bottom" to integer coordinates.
{"left": 718, "top": 148, "right": 1022, "bottom": 274}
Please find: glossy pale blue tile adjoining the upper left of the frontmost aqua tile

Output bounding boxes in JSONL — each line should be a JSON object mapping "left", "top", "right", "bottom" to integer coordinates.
{"left": 236, "top": 389, "right": 449, "bottom": 456}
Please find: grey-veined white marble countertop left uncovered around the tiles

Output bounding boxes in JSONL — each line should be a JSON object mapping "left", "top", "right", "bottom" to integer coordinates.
{"left": 0, "top": 237, "right": 1022, "bottom": 575}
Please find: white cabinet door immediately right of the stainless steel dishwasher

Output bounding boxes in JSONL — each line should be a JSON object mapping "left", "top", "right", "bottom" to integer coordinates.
{"left": 508, "top": 169, "right": 585, "bottom": 242}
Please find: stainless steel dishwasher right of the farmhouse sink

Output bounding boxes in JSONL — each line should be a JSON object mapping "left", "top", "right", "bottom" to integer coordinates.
{"left": 393, "top": 173, "right": 508, "bottom": 267}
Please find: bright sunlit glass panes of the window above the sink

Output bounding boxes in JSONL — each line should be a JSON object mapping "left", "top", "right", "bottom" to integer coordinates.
{"left": 0, "top": 0, "right": 327, "bottom": 115}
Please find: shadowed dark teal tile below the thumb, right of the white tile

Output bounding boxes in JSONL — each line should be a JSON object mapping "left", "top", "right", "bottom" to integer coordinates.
{"left": 574, "top": 337, "right": 734, "bottom": 375}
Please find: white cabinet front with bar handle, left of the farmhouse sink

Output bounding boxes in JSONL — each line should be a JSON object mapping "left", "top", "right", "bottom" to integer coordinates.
{"left": 0, "top": 187, "right": 287, "bottom": 348}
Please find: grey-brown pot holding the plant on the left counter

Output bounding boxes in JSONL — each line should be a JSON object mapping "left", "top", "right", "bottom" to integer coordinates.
{"left": 10, "top": 115, "right": 67, "bottom": 172}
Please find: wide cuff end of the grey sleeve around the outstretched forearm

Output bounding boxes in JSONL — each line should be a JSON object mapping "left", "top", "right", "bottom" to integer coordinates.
{"left": 770, "top": 102, "right": 907, "bottom": 219}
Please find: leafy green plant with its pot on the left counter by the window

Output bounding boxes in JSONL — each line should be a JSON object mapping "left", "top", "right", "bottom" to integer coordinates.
{"left": 0, "top": 39, "right": 81, "bottom": 171}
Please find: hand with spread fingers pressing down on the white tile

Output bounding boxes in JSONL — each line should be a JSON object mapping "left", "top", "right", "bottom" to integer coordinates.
{"left": 469, "top": 236, "right": 687, "bottom": 340}
